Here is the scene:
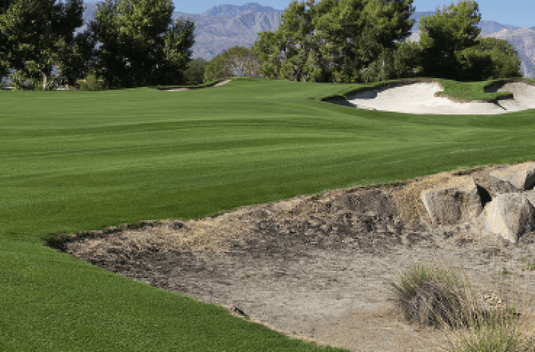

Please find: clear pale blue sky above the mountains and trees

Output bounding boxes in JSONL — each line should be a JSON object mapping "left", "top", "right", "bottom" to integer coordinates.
{"left": 173, "top": 0, "right": 535, "bottom": 28}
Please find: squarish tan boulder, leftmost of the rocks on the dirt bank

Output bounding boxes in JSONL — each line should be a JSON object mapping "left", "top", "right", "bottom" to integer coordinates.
{"left": 420, "top": 178, "right": 483, "bottom": 225}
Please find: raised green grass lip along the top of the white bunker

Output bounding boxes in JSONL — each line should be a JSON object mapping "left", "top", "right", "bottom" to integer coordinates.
{"left": 324, "top": 78, "right": 535, "bottom": 102}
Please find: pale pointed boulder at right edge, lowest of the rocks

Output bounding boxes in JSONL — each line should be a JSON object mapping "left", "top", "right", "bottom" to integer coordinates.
{"left": 485, "top": 193, "right": 535, "bottom": 243}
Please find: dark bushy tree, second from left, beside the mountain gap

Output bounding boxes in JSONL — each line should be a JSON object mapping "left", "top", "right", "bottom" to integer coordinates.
{"left": 89, "top": 0, "right": 195, "bottom": 87}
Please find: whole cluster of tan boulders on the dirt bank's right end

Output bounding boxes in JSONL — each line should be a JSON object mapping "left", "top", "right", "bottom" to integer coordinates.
{"left": 420, "top": 162, "right": 535, "bottom": 243}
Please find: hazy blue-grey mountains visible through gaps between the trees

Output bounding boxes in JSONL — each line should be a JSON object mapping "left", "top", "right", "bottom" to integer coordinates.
{"left": 81, "top": 2, "right": 535, "bottom": 76}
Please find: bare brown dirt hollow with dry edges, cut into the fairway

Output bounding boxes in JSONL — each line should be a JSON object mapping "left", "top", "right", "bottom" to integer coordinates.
{"left": 57, "top": 164, "right": 535, "bottom": 352}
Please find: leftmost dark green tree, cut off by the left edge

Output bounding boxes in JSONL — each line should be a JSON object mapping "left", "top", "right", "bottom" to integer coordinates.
{"left": 0, "top": 0, "right": 83, "bottom": 90}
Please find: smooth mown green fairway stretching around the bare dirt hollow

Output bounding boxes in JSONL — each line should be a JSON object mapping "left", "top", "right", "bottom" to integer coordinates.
{"left": 0, "top": 79, "right": 535, "bottom": 351}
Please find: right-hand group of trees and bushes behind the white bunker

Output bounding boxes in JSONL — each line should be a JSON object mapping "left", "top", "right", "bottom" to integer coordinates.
{"left": 205, "top": 0, "right": 521, "bottom": 83}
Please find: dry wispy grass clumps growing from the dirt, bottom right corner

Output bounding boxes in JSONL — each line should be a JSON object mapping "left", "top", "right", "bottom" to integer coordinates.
{"left": 392, "top": 264, "right": 535, "bottom": 352}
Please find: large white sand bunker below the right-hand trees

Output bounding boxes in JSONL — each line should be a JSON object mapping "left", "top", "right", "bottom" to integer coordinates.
{"left": 335, "top": 82, "right": 535, "bottom": 115}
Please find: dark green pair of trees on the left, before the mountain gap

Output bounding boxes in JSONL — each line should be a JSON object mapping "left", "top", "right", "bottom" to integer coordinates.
{"left": 0, "top": 0, "right": 195, "bottom": 90}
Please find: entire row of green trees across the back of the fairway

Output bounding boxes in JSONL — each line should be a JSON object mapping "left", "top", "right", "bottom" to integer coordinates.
{"left": 0, "top": 0, "right": 521, "bottom": 90}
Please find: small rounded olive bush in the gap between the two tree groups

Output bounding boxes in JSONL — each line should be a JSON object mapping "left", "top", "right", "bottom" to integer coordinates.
{"left": 204, "top": 46, "right": 259, "bottom": 82}
